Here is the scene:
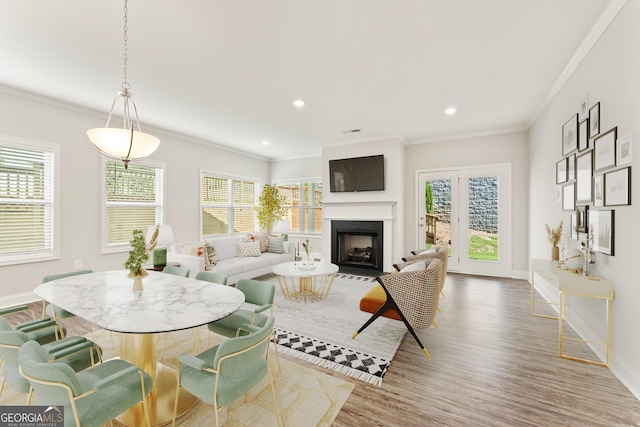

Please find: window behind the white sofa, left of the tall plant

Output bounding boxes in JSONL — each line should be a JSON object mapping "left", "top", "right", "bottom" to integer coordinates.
{"left": 200, "top": 172, "right": 258, "bottom": 236}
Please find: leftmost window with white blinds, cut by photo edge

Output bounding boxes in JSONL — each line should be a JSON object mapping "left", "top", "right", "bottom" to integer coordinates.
{"left": 0, "top": 137, "right": 59, "bottom": 265}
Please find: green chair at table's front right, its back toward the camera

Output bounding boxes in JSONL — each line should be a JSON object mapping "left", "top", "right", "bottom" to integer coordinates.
{"left": 173, "top": 316, "right": 280, "bottom": 426}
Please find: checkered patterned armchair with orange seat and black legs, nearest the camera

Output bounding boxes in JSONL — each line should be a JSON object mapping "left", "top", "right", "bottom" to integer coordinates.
{"left": 353, "top": 259, "right": 443, "bottom": 359}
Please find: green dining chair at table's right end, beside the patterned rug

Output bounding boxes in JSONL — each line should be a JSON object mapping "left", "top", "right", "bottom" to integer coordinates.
{"left": 207, "top": 279, "right": 280, "bottom": 369}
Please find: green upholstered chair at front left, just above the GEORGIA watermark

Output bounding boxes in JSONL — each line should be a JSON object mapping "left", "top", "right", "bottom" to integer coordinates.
{"left": 18, "top": 341, "right": 152, "bottom": 427}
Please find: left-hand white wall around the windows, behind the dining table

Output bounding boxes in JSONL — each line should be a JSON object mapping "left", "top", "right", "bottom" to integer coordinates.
{"left": 0, "top": 88, "right": 269, "bottom": 306}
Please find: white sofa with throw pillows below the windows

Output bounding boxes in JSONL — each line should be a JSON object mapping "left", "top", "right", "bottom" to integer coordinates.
{"left": 167, "top": 233, "right": 294, "bottom": 285}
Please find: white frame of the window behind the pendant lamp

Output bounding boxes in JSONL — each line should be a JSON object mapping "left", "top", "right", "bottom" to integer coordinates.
{"left": 101, "top": 156, "right": 167, "bottom": 254}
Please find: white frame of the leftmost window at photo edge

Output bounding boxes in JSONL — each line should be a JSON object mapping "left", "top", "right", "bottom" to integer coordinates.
{"left": 0, "top": 135, "right": 60, "bottom": 266}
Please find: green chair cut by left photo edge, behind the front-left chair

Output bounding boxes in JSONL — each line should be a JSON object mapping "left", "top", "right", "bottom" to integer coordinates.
{"left": 0, "top": 319, "right": 102, "bottom": 404}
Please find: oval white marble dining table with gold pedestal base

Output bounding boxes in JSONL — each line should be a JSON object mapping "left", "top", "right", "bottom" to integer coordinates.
{"left": 33, "top": 270, "right": 244, "bottom": 426}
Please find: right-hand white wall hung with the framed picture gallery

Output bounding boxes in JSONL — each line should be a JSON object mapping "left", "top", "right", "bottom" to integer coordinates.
{"left": 529, "top": 1, "right": 640, "bottom": 398}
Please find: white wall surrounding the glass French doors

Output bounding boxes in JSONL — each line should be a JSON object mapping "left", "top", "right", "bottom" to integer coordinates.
{"left": 404, "top": 132, "right": 529, "bottom": 277}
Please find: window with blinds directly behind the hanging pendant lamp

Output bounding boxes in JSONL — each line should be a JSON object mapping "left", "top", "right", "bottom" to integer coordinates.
{"left": 103, "top": 159, "right": 164, "bottom": 252}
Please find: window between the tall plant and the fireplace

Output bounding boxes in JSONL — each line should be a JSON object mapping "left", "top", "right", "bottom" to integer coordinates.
{"left": 277, "top": 180, "right": 322, "bottom": 233}
